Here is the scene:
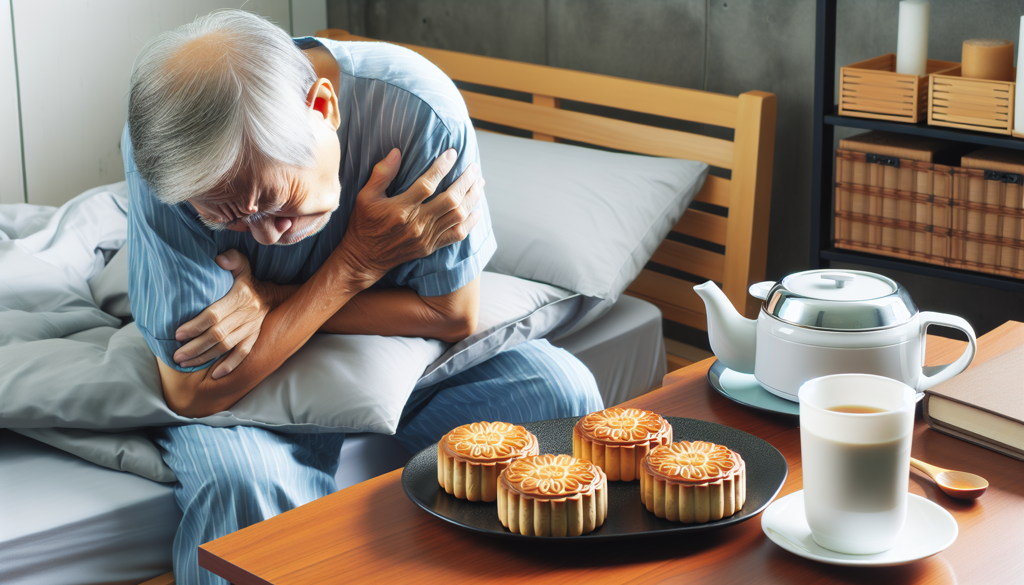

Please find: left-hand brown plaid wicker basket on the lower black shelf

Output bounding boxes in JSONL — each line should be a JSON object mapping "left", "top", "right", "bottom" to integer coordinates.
{"left": 835, "top": 132, "right": 955, "bottom": 265}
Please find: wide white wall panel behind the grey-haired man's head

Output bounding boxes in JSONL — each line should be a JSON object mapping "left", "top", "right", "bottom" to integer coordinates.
{"left": 11, "top": 0, "right": 292, "bottom": 205}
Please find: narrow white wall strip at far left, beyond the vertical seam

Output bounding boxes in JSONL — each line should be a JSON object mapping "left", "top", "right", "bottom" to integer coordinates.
{"left": 0, "top": 0, "right": 25, "bottom": 203}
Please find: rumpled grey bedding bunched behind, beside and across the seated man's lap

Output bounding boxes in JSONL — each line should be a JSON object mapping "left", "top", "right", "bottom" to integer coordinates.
{"left": 0, "top": 183, "right": 581, "bottom": 482}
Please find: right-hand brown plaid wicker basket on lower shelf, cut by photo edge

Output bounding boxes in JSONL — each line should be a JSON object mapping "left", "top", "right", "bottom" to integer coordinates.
{"left": 950, "top": 148, "right": 1024, "bottom": 278}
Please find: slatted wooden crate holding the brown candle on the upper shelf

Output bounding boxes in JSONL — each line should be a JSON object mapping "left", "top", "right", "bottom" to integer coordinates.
{"left": 928, "top": 66, "right": 1015, "bottom": 134}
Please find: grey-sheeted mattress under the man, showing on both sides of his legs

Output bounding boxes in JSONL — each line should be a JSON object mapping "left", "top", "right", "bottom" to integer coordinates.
{"left": 0, "top": 296, "right": 666, "bottom": 585}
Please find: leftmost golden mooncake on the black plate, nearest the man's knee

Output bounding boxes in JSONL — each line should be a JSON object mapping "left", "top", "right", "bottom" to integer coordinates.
{"left": 437, "top": 422, "right": 538, "bottom": 502}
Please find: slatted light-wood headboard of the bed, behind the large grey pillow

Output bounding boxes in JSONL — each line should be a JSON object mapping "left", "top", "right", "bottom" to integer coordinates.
{"left": 316, "top": 29, "right": 775, "bottom": 330}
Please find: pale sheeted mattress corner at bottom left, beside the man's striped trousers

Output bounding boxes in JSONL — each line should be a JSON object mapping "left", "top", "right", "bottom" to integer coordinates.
{"left": 0, "top": 430, "right": 181, "bottom": 585}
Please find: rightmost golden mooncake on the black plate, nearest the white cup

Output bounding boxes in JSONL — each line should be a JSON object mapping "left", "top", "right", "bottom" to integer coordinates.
{"left": 640, "top": 441, "right": 746, "bottom": 524}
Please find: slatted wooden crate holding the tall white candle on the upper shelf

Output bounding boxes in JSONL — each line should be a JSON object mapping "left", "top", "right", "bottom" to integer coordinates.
{"left": 839, "top": 53, "right": 959, "bottom": 124}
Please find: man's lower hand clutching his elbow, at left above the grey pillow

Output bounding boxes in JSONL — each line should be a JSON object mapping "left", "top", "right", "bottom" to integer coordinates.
{"left": 174, "top": 250, "right": 286, "bottom": 380}
